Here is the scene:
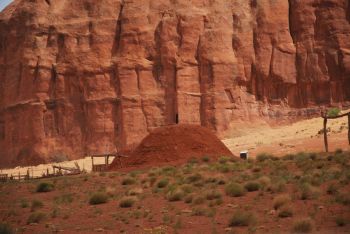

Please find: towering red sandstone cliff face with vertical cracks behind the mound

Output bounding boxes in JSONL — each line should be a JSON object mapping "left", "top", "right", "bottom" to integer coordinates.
{"left": 0, "top": 0, "right": 350, "bottom": 166}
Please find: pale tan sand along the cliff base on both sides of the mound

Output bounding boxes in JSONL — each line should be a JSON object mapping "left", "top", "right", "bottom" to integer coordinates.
{"left": 0, "top": 115, "right": 350, "bottom": 177}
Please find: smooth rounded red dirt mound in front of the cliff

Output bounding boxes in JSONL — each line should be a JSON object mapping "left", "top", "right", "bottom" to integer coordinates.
{"left": 111, "top": 125, "right": 233, "bottom": 169}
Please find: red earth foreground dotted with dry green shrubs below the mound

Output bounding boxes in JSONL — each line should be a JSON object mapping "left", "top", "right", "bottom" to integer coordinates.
{"left": 0, "top": 151, "right": 350, "bottom": 233}
